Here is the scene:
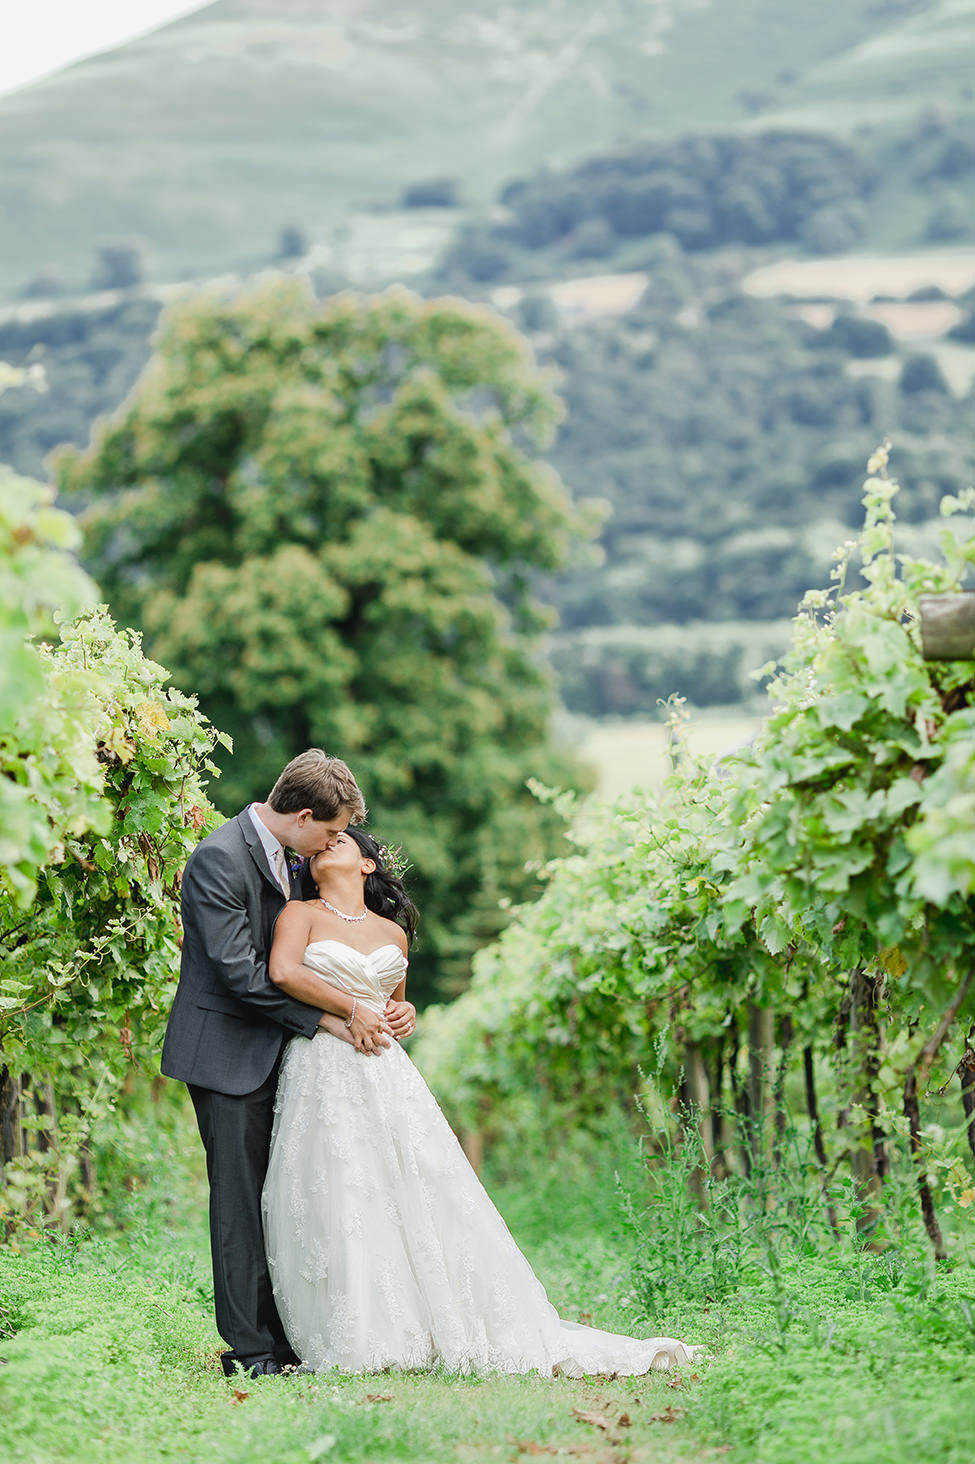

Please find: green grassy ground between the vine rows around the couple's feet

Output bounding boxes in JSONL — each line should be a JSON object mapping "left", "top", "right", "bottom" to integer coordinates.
{"left": 0, "top": 1104, "right": 975, "bottom": 1464}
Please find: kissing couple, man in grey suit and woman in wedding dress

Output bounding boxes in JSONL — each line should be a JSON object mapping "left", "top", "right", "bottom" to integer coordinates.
{"left": 163, "top": 748, "right": 695, "bottom": 1376}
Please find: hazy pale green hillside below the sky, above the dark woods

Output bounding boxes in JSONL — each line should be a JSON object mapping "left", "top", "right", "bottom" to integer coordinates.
{"left": 0, "top": 0, "right": 975, "bottom": 294}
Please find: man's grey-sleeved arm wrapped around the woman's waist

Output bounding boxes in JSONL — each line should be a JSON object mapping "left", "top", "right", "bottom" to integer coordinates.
{"left": 182, "top": 846, "right": 324, "bottom": 1037}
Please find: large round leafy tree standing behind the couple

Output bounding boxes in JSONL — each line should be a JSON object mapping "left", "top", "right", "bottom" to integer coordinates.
{"left": 59, "top": 280, "right": 584, "bottom": 990}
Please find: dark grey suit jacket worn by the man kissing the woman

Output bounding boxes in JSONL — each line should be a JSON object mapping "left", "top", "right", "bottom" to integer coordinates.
{"left": 163, "top": 810, "right": 322, "bottom": 1095}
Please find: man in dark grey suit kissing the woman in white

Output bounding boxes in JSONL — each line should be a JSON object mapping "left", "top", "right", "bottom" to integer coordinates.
{"left": 163, "top": 748, "right": 388, "bottom": 1376}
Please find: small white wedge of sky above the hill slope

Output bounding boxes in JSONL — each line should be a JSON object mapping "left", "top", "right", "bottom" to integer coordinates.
{"left": 0, "top": 0, "right": 206, "bottom": 92}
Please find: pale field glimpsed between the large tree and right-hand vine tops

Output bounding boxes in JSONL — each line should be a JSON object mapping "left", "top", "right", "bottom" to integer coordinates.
{"left": 578, "top": 714, "right": 761, "bottom": 798}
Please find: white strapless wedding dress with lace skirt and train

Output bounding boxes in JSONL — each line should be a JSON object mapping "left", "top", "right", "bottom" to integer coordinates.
{"left": 264, "top": 940, "right": 698, "bottom": 1378}
